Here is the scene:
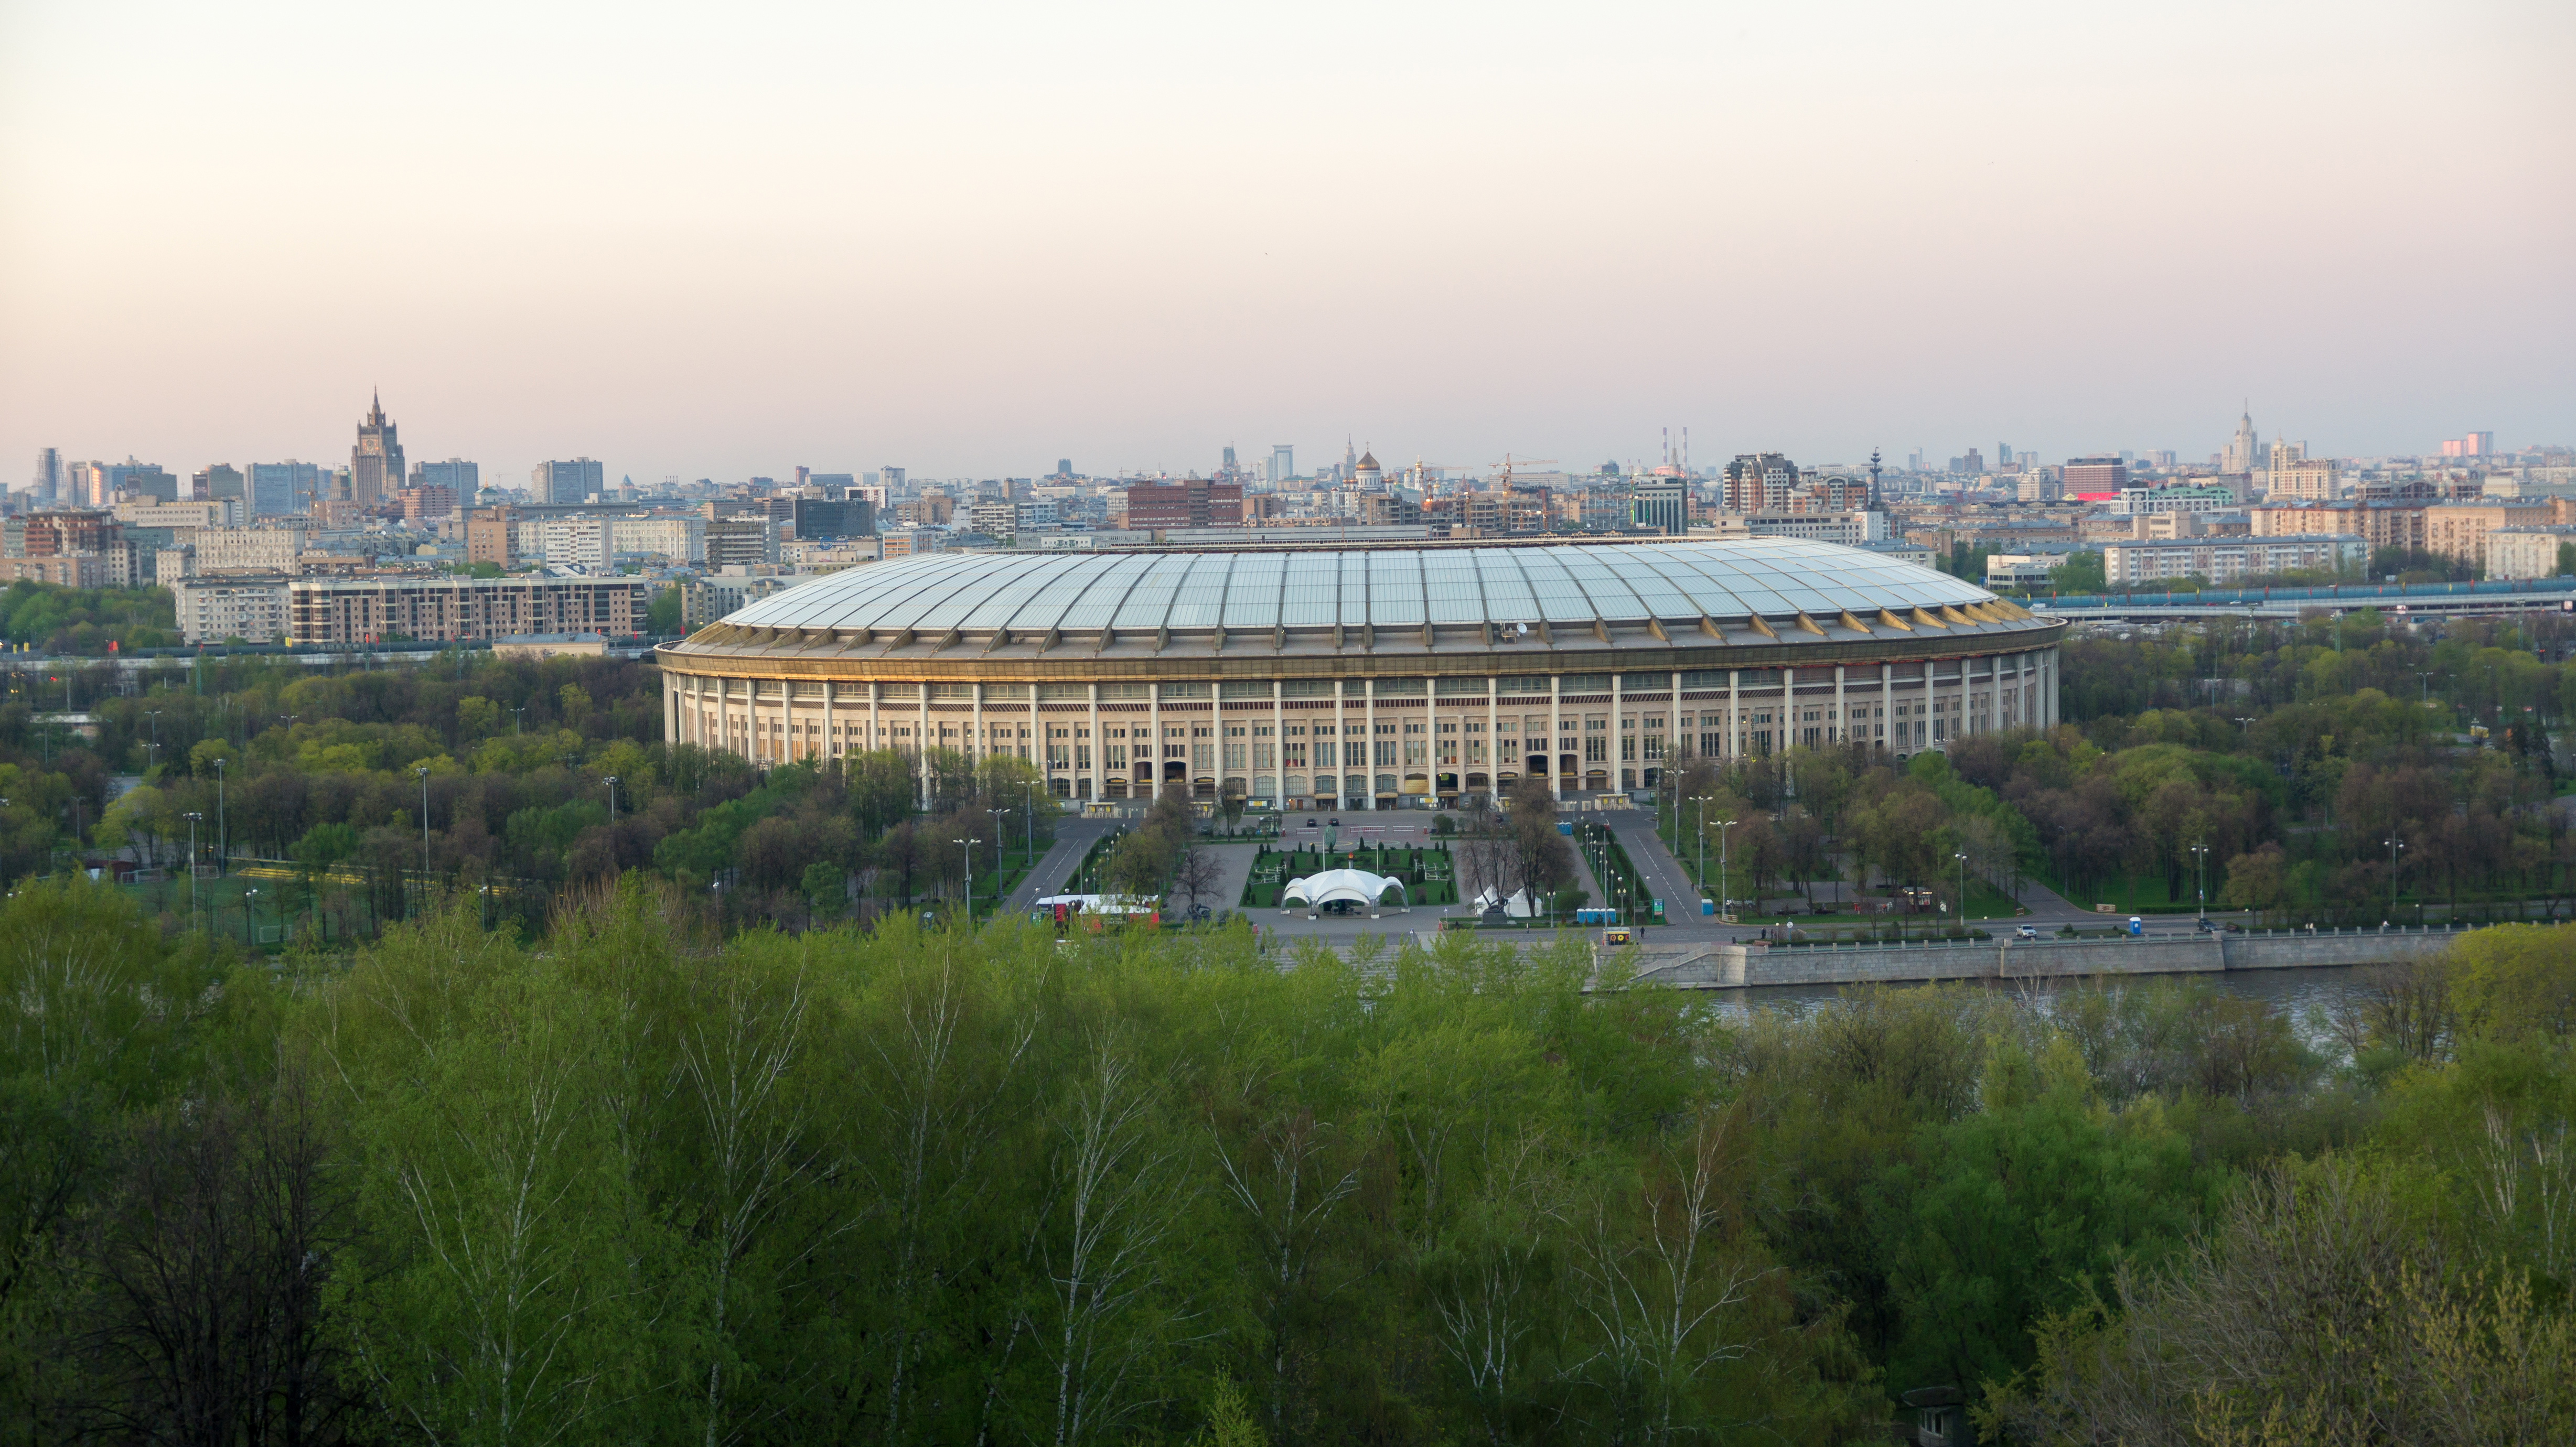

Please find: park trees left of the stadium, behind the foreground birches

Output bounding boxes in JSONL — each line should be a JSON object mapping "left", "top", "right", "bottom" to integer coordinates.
{"left": 0, "top": 654, "right": 1054, "bottom": 932}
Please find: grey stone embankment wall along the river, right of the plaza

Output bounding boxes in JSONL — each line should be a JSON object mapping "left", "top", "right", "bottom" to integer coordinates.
{"left": 1605, "top": 930, "right": 2465, "bottom": 989}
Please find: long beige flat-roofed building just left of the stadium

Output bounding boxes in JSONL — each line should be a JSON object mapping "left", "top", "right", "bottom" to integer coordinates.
{"left": 286, "top": 577, "right": 652, "bottom": 644}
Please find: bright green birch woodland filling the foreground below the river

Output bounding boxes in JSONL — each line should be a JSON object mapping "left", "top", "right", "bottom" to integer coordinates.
{"left": 0, "top": 876, "right": 2576, "bottom": 1447}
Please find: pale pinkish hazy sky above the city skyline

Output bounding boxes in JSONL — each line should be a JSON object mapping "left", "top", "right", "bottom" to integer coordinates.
{"left": 0, "top": 0, "right": 2576, "bottom": 487}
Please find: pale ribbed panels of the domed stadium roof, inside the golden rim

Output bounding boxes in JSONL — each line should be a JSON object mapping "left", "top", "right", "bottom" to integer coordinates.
{"left": 724, "top": 538, "right": 1994, "bottom": 636}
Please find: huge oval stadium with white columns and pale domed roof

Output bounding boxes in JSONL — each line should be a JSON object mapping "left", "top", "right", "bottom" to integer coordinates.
{"left": 657, "top": 538, "right": 2066, "bottom": 808}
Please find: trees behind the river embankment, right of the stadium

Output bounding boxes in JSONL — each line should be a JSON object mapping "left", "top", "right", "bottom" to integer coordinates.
{"left": 1664, "top": 613, "right": 2576, "bottom": 924}
